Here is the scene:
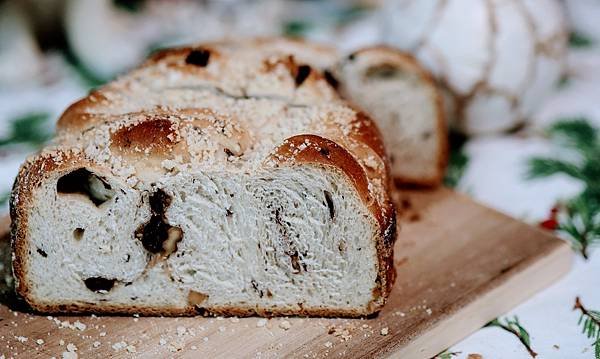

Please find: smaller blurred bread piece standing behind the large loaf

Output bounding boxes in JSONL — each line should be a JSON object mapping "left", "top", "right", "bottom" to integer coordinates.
{"left": 333, "top": 46, "right": 448, "bottom": 186}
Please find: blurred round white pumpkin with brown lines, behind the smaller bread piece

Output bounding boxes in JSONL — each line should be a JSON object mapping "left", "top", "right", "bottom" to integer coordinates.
{"left": 383, "top": 0, "right": 567, "bottom": 134}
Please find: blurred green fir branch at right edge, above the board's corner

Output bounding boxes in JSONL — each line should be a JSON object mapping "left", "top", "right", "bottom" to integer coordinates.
{"left": 527, "top": 118, "right": 600, "bottom": 259}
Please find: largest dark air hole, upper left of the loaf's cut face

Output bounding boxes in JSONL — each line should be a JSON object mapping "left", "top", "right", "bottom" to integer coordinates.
{"left": 56, "top": 168, "right": 115, "bottom": 206}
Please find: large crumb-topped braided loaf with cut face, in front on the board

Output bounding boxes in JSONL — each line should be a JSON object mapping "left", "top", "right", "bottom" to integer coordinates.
{"left": 11, "top": 39, "right": 395, "bottom": 316}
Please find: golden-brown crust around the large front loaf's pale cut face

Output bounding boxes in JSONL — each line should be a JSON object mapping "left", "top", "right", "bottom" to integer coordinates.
{"left": 10, "top": 40, "right": 396, "bottom": 317}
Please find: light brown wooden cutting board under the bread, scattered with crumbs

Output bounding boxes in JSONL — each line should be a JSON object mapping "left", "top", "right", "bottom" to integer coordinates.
{"left": 0, "top": 189, "right": 572, "bottom": 358}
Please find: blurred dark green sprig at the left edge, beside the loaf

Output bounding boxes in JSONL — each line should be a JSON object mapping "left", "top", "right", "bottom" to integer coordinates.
{"left": 0, "top": 112, "right": 52, "bottom": 147}
